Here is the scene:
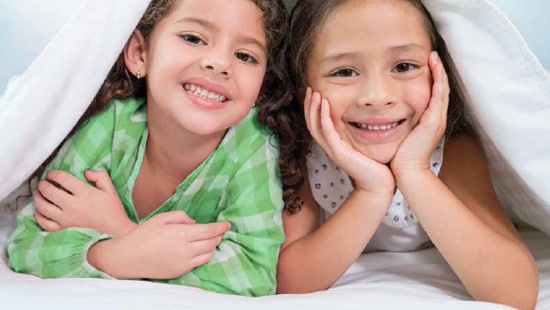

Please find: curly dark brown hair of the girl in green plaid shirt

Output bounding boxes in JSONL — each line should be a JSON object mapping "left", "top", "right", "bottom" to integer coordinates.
{"left": 29, "top": 0, "right": 292, "bottom": 186}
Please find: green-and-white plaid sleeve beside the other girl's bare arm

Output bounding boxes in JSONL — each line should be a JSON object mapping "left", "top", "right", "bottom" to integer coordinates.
{"left": 155, "top": 123, "right": 284, "bottom": 296}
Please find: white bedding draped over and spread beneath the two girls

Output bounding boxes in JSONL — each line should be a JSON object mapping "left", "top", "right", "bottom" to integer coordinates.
{"left": 0, "top": 0, "right": 550, "bottom": 310}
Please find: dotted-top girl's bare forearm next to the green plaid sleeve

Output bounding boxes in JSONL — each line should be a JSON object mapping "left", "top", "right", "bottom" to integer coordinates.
{"left": 277, "top": 191, "right": 391, "bottom": 293}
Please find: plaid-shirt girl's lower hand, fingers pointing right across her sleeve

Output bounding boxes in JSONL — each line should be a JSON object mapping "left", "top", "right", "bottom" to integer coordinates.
{"left": 88, "top": 211, "right": 230, "bottom": 279}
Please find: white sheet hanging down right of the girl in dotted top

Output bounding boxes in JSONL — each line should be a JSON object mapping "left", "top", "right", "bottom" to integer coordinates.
{"left": 423, "top": 0, "right": 550, "bottom": 235}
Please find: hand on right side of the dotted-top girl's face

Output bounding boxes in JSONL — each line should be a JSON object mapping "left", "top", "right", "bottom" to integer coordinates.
{"left": 391, "top": 52, "right": 450, "bottom": 176}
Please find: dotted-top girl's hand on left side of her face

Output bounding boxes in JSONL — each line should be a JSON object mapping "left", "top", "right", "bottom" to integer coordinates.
{"left": 304, "top": 87, "right": 395, "bottom": 195}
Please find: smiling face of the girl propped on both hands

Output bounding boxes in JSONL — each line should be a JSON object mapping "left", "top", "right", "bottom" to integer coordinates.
{"left": 306, "top": 0, "right": 432, "bottom": 163}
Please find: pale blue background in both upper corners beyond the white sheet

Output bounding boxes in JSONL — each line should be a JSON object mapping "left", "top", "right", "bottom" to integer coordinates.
{"left": 0, "top": 0, "right": 550, "bottom": 93}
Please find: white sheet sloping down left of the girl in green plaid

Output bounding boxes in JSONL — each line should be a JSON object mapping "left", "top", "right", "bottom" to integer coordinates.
{"left": 0, "top": 0, "right": 149, "bottom": 200}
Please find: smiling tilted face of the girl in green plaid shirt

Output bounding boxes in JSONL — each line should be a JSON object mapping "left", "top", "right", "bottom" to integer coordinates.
{"left": 144, "top": 0, "right": 267, "bottom": 137}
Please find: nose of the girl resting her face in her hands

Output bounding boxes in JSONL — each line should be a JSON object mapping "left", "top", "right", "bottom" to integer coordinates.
{"left": 358, "top": 73, "right": 395, "bottom": 108}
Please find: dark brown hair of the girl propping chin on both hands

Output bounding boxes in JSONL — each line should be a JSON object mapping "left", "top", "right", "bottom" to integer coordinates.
{"left": 281, "top": 0, "right": 472, "bottom": 213}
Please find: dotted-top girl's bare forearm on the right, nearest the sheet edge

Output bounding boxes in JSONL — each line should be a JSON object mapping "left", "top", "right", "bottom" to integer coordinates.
{"left": 396, "top": 171, "right": 538, "bottom": 309}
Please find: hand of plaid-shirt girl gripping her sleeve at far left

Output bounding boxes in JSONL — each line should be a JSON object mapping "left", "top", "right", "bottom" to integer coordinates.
{"left": 33, "top": 170, "right": 137, "bottom": 237}
